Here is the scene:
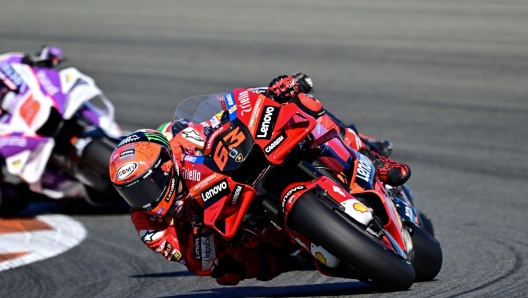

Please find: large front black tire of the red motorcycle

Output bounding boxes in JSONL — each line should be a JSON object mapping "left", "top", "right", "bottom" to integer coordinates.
{"left": 288, "top": 192, "right": 414, "bottom": 291}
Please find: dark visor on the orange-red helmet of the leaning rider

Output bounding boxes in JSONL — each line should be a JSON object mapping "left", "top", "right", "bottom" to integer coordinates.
{"left": 116, "top": 149, "right": 173, "bottom": 211}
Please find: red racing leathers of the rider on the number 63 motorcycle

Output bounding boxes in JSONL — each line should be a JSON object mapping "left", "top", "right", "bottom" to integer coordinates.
{"left": 131, "top": 89, "right": 408, "bottom": 285}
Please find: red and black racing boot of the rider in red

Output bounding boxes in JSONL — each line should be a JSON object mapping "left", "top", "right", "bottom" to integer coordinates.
{"left": 359, "top": 149, "right": 411, "bottom": 187}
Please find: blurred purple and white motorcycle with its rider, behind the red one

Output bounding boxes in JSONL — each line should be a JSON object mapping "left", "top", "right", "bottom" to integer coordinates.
{"left": 0, "top": 47, "right": 123, "bottom": 210}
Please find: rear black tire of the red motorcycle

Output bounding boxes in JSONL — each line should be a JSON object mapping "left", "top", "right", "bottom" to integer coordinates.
{"left": 411, "top": 227, "right": 443, "bottom": 282}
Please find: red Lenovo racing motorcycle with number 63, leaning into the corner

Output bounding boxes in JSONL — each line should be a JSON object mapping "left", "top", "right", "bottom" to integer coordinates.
{"left": 175, "top": 89, "right": 442, "bottom": 290}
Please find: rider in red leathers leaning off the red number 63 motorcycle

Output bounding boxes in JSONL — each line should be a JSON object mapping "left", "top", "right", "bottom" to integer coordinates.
{"left": 109, "top": 76, "right": 410, "bottom": 285}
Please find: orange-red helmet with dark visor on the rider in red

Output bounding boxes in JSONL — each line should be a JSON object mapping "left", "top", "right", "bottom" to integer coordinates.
{"left": 109, "top": 129, "right": 180, "bottom": 216}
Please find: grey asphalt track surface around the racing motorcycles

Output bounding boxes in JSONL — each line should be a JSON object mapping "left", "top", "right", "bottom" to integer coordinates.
{"left": 0, "top": 0, "right": 528, "bottom": 297}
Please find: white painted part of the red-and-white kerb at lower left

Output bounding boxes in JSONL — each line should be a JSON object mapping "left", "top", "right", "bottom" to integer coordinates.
{"left": 0, "top": 214, "right": 86, "bottom": 271}
